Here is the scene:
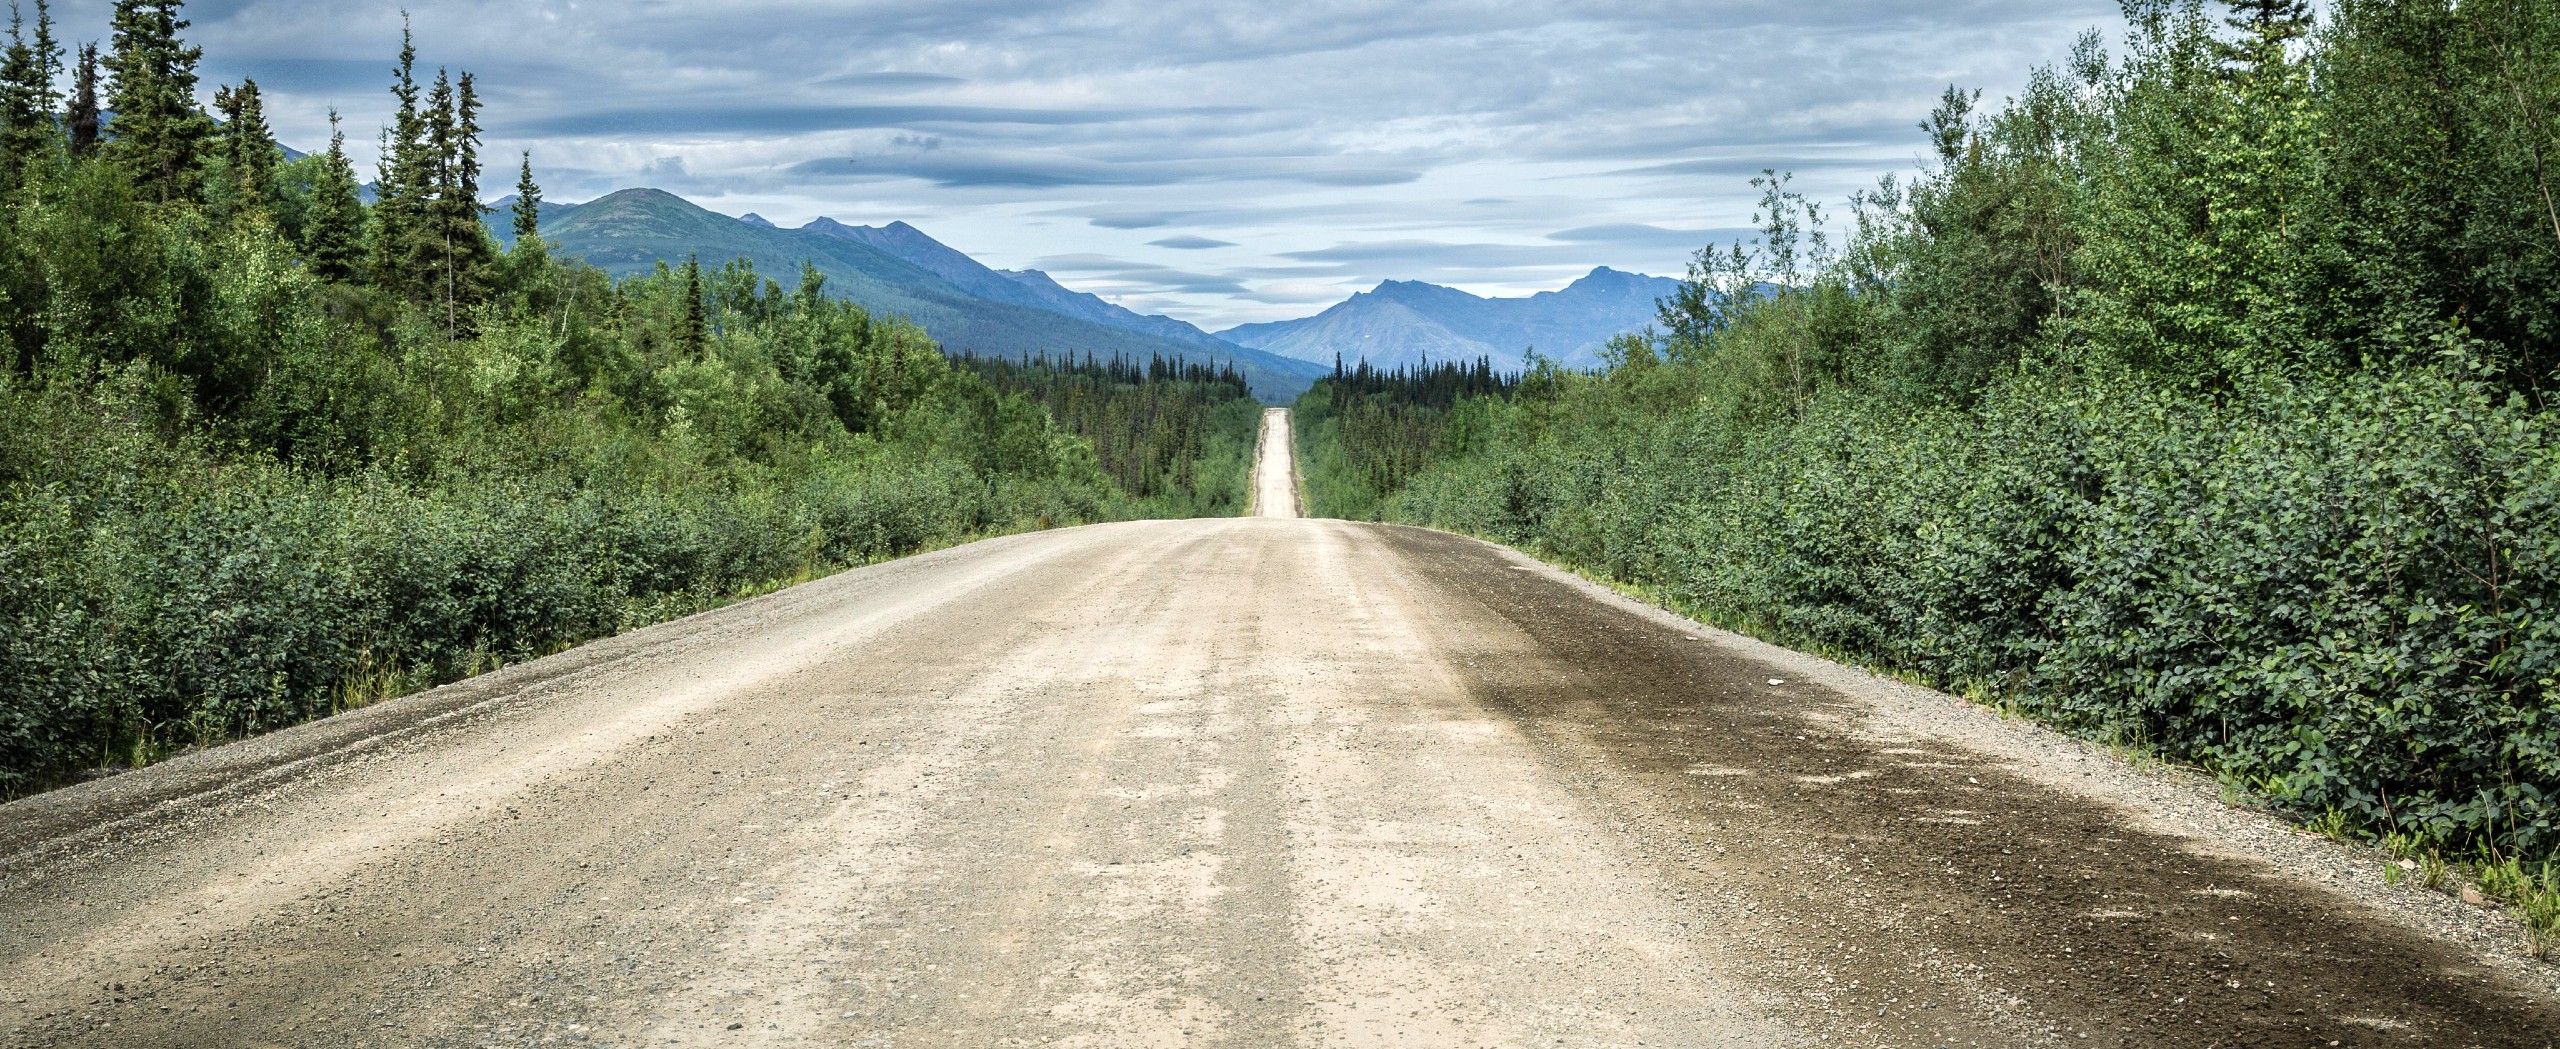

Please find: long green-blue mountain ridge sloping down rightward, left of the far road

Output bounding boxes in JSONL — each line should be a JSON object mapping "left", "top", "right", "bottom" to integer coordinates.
{"left": 489, "top": 189, "right": 1324, "bottom": 402}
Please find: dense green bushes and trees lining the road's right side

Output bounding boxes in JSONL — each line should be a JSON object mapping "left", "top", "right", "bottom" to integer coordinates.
{"left": 1300, "top": 0, "right": 2560, "bottom": 869}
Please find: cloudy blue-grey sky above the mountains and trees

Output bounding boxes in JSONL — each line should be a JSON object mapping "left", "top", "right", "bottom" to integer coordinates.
{"left": 80, "top": 0, "right": 2120, "bottom": 330}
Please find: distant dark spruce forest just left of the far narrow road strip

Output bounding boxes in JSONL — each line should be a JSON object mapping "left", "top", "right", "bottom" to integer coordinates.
{"left": 960, "top": 353, "right": 1262, "bottom": 517}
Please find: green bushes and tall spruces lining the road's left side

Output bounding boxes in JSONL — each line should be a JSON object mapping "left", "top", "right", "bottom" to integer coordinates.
{"left": 0, "top": 0, "right": 1231, "bottom": 796}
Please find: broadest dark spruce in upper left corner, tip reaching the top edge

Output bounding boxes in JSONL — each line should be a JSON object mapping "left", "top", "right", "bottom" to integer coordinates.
{"left": 108, "top": 0, "right": 212, "bottom": 202}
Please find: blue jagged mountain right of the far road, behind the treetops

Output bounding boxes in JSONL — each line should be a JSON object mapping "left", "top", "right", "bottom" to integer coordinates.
{"left": 1219, "top": 266, "right": 1679, "bottom": 368}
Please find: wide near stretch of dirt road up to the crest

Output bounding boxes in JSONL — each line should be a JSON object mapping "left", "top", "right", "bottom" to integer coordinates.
{"left": 0, "top": 414, "right": 2560, "bottom": 1046}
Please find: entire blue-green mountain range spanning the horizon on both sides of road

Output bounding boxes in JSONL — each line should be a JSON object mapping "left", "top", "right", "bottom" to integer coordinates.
{"left": 489, "top": 189, "right": 1677, "bottom": 402}
